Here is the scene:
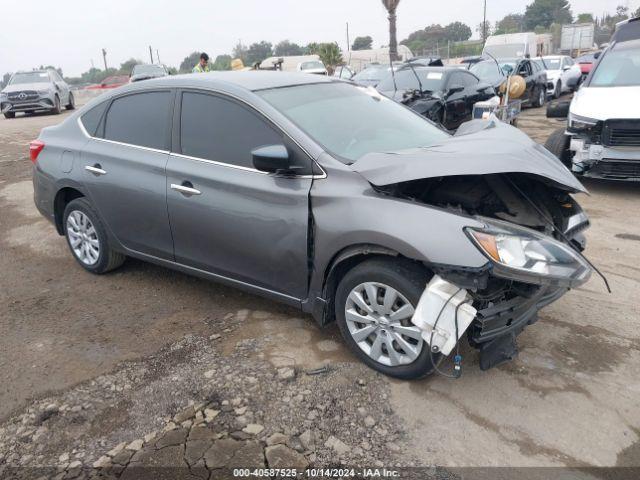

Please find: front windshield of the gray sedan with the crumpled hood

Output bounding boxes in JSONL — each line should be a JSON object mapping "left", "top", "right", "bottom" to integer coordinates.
{"left": 256, "top": 83, "right": 449, "bottom": 163}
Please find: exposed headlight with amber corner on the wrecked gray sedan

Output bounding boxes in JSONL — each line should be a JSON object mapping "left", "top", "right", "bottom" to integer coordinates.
{"left": 465, "top": 219, "right": 591, "bottom": 286}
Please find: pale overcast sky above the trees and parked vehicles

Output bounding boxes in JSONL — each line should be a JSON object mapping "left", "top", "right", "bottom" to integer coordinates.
{"left": 0, "top": 0, "right": 640, "bottom": 76}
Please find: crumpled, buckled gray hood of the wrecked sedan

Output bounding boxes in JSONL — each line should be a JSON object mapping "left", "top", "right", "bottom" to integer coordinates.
{"left": 351, "top": 117, "right": 586, "bottom": 193}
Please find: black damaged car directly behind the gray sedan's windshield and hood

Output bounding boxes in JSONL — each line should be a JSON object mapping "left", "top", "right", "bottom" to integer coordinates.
{"left": 376, "top": 65, "right": 495, "bottom": 130}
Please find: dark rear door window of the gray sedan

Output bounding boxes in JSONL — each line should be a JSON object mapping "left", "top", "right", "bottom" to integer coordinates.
{"left": 104, "top": 91, "right": 173, "bottom": 150}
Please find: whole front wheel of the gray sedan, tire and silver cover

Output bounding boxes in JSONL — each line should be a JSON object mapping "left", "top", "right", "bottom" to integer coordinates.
{"left": 335, "top": 259, "right": 440, "bottom": 379}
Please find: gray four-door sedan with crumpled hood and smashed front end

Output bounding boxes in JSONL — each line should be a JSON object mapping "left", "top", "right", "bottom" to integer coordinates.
{"left": 30, "top": 72, "right": 591, "bottom": 378}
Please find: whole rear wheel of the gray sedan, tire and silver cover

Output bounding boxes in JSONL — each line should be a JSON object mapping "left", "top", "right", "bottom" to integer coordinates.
{"left": 63, "top": 198, "right": 125, "bottom": 274}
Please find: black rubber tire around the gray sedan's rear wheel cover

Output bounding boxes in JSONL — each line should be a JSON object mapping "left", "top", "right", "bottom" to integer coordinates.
{"left": 62, "top": 197, "right": 126, "bottom": 274}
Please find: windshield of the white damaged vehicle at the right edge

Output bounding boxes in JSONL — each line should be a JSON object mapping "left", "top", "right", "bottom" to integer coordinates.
{"left": 589, "top": 40, "right": 640, "bottom": 87}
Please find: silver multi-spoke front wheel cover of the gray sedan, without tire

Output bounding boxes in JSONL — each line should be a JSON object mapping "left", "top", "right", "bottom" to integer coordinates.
{"left": 345, "top": 282, "right": 424, "bottom": 367}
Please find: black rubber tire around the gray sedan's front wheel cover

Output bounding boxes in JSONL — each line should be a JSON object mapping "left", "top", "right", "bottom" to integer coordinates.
{"left": 334, "top": 258, "right": 440, "bottom": 380}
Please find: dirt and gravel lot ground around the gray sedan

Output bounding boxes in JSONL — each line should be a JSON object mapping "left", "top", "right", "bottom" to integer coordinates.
{"left": 0, "top": 102, "right": 640, "bottom": 478}
